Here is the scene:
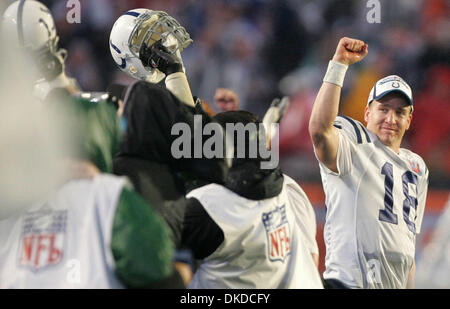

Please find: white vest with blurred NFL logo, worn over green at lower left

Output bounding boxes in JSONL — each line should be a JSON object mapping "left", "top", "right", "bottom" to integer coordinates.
{"left": 0, "top": 175, "right": 125, "bottom": 288}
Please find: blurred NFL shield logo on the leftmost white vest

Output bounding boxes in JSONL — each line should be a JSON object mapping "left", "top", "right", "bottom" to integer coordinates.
{"left": 19, "top": 209, "right": 67, "bottom": 271}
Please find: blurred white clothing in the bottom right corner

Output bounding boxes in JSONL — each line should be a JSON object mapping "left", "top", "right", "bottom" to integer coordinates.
{"left": 415, "top": 197, "right": 450, "bottom": 289}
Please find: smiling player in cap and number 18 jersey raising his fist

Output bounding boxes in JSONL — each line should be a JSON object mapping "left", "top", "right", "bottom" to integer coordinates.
{"left": 309, "top": 37, "right": 428, "bottom": 288}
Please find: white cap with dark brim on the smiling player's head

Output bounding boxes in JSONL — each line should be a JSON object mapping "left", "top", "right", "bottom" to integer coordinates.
{"left": 367, "top": 75, "right": 413, "bottom": 107}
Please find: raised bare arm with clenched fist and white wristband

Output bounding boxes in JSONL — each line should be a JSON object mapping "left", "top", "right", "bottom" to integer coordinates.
{"left": 309, "top": 37, "right": 368, "bottom": 172}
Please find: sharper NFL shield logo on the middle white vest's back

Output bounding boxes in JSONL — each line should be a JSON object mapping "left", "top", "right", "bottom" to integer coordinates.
{"left": 262, "top": 205, "right": 291, "bottom": 263}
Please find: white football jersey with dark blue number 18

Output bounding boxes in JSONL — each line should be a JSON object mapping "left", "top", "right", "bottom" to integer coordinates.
{"left": 319, "top": 116, "right": 428, "bottom": 288}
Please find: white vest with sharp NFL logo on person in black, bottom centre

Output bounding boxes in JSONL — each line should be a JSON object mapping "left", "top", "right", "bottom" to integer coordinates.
{"left": 187, "top": 176, "right": 323, "bottom": 289}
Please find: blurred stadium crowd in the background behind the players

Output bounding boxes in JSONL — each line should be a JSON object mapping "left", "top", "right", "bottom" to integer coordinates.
{"left": 2, "top": 0, "right": 450, "bottom": 271}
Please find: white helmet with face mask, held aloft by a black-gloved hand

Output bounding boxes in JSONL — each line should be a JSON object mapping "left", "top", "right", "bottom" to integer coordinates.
{"left": 109, "top": 9, "right": 192, "bottom": 83}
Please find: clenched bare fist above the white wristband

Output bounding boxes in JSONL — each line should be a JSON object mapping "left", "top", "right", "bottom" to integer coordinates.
{"left": 333, "top": 37, "right": 369, "bottom": 65}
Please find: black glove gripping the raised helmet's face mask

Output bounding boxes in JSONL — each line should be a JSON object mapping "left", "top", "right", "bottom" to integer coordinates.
{"left": 139, "top": 40, "right": 183, "bottom": 76}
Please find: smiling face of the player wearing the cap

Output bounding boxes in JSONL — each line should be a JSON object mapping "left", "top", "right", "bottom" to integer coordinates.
{"left": 364, "top": 93, "right": 412, "bottom": 152}
